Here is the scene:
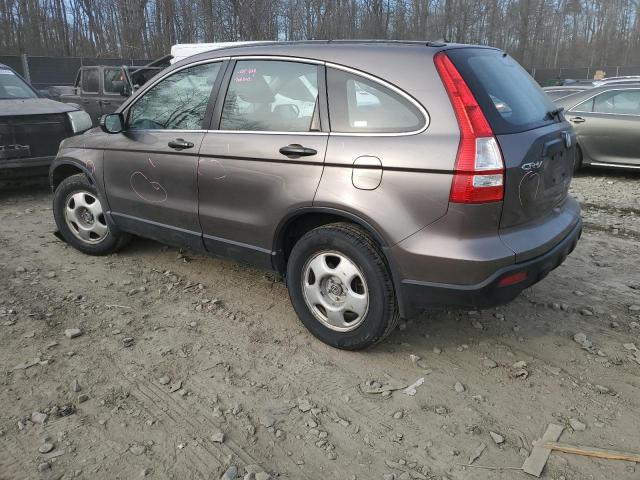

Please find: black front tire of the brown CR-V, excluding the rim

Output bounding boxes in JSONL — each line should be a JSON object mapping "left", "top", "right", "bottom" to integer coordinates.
{"left": 53, "top": 174, "right": 130, "bottom": 255}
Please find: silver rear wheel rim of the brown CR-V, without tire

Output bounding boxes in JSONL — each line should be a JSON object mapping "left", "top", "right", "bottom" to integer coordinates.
{"left": 302, "top": 250, "right": 369, "bottom": 332}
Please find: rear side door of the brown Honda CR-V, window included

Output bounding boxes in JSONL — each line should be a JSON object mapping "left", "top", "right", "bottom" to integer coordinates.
{"left": 198, "top": 59, "right": 328, "bottom": 268}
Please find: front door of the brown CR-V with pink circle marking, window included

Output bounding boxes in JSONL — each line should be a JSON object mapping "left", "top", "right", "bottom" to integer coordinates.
{"left": 104, "top": 62, "right": 221, "bottom": 249}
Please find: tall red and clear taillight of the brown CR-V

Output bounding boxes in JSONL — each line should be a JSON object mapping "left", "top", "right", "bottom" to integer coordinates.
{"left": 434, "top": 52, "right": 504, "bottom": 203}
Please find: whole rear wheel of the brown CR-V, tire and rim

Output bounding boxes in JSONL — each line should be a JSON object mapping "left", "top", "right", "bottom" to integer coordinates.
{"left": 287, "top": 223, "right": 399, "bottom": 350}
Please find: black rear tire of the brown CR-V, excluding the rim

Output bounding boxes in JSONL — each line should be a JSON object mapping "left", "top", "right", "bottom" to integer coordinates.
{"left": 287, "top": 223, "right": 399, "bottom": 350}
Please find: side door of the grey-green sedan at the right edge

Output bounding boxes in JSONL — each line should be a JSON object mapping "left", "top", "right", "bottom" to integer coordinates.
{"left": 567, "top": 86, "right": 640, "bottom": 165}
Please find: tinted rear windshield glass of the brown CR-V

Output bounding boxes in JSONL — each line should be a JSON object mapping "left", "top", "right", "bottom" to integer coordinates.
{"left": 447, "top": 48, "right": 555, "bottom": 134}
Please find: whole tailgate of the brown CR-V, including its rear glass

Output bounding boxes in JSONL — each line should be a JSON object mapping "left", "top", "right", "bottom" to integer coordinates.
{"left": 447, "top": 48, "right": 576, "bottom": 229}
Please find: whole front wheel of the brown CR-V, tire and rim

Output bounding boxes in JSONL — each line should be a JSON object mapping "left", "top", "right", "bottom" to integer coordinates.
{"left": 53, "top": 174, "right": 129, "bottom": 255}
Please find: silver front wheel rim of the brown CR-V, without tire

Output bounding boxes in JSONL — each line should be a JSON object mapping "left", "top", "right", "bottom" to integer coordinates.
{"left": 64, "top": 191, "right": 109, "bottom": 245}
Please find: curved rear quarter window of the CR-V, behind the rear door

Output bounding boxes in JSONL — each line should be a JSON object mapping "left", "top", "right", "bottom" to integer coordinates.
{"left": 327, "top": 68, "right": 425, "bottom": 133}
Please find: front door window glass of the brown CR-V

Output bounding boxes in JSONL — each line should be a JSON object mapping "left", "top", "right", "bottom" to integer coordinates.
{"left": 128, "top": 62, "right": 220, "bottom": 130}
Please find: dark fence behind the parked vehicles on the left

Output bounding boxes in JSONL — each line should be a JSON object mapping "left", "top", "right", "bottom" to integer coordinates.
{"left": 0, "top": 55, "right": 150, "bottom": 90}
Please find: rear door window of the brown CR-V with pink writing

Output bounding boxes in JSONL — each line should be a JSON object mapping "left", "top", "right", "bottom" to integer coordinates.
{"left": 220, "top": 60, "right": 318, "bottom": 132}
